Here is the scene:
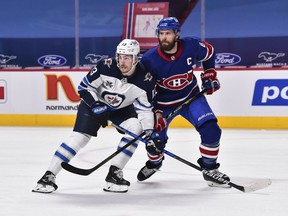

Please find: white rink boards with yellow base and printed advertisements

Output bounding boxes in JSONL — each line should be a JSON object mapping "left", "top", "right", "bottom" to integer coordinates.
{"left": 0, "top": 68, "right": 288, "bottom": 129}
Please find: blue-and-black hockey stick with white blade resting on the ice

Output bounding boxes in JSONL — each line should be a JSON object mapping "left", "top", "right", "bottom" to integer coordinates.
{"left": 112, "top": 124, "right": 272, "bottom": 193}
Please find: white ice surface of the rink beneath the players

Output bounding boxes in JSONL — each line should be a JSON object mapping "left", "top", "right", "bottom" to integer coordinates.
{"left": 0, "top": 127, "right": 288, "bottom": 216}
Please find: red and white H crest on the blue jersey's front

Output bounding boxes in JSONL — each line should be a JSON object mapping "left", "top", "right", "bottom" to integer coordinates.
{"left": 158, "top": 70, "right": 193, "bottom": 90}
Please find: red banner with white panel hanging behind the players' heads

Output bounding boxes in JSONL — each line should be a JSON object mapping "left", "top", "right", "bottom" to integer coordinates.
{"left": 122, "top": 2, "right": 169, "bottom": 50}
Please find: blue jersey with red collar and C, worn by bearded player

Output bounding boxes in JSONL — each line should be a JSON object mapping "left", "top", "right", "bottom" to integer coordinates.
{"left": 141, "top": 37, "right": 215, "bottom": 110}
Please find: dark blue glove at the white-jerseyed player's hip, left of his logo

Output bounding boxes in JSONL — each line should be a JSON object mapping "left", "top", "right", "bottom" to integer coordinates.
{"left": 91, "top": 101, "right": 110, "bottom": 128}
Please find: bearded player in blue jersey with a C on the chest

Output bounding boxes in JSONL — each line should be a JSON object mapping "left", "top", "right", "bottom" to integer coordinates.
{"left": 137, "top": 17, "right": 229, "bottom": 187}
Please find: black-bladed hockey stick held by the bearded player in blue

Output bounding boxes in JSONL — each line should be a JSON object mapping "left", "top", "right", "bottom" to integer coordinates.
{"left": 61, "top": 89, "right": 207, "bottom": 175}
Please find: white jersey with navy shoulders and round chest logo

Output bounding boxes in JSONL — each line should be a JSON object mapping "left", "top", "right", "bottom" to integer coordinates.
{"left": 78, "top": 58, "right": 156, "bottom": 130}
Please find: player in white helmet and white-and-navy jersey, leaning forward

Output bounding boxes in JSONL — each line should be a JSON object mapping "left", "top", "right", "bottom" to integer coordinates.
{"left": 32, "top": 39, "right": 157, "bottom": 193}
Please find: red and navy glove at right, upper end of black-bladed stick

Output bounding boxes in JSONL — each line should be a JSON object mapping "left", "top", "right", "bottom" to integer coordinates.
{"left": 201, "top": 68, "right": 220, "bottom": 95}
